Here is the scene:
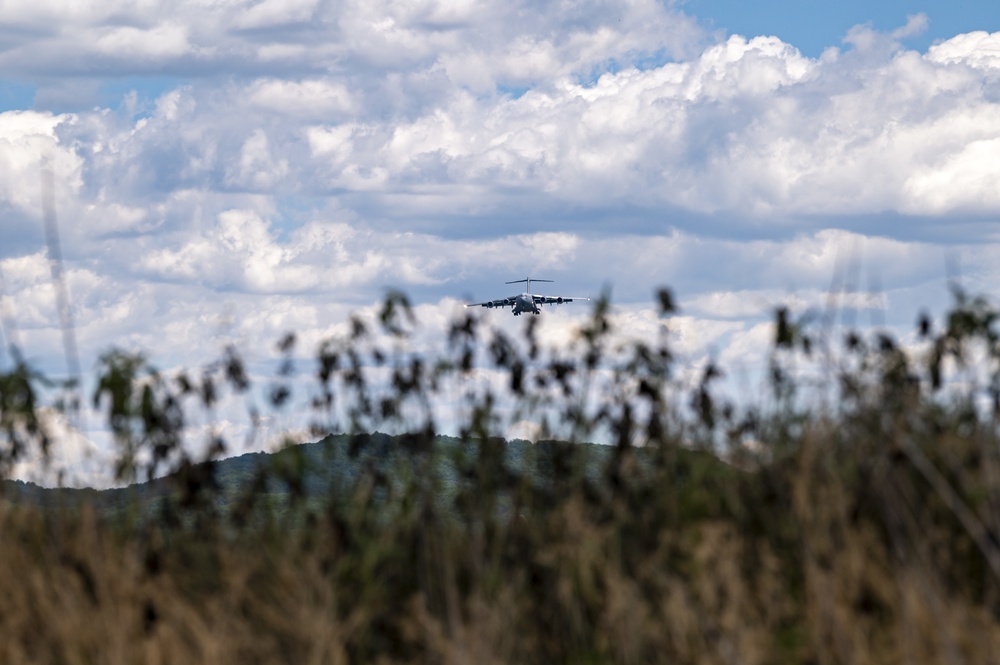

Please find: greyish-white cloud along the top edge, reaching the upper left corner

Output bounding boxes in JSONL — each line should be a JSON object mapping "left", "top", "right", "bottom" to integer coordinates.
{"left": 0, "top": 0, "right": 700, "bottom": 89}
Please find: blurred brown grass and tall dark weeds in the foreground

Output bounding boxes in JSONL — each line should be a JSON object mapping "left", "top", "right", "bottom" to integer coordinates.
{"left": 0, "top": 292, "right": 1000, "bottom": 663}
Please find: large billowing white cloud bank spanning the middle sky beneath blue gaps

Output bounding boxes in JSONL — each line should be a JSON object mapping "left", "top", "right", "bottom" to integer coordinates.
{"left": 19, "top": 24, "right": 1000, "bottom": 241}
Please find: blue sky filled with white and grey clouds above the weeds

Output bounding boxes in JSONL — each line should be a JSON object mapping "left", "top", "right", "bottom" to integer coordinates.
{"left": 0, "top": 0, "right": 1000, "bottom": 483}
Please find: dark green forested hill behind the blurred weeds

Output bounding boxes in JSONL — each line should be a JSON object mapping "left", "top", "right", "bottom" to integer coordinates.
{"left": 3, "top": 432, "right": 731, "bottom": 515}
